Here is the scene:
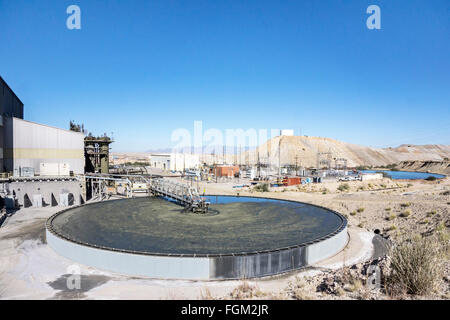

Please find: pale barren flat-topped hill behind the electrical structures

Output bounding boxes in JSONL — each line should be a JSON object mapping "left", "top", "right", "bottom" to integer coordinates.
{"left": 242, "top": 136, "right": 450, "bottom": 167}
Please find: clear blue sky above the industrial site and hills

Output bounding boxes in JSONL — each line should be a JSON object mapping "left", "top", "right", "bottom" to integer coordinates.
{"left": 0, "top": 0, "right": 450, "bottom": 151}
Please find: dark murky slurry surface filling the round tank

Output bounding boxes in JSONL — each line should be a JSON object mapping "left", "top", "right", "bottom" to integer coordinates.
{"left": 52, "top": 196, "right": 343, "bottom": 254}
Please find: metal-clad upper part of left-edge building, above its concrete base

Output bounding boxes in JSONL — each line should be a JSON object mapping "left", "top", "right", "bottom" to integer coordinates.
{"left": 0, "top": 77, "right": 85, "bottom": 176}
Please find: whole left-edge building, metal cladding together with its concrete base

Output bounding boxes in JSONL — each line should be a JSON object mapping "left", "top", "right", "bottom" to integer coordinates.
{"left": 0, "top": 77, "right": 85, "bottom": 210}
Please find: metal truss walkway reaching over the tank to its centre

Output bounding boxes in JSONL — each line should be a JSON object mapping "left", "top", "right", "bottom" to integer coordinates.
{"left": 150, "top": 179, "right": 210, "bottom": 213}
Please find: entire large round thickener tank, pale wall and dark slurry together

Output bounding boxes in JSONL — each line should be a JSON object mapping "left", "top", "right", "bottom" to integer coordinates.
{"left": 47, "top": 196, "right": 348, "bottom": 280}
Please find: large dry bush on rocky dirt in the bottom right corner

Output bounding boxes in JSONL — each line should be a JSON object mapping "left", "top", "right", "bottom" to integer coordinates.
{"left": 386, "top": 236, "right": 443, "bottom": 296}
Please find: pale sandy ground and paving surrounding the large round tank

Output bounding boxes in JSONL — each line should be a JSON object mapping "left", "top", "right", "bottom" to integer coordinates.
{"left": 0, "top": 178, "right": 450, "bottom": 299}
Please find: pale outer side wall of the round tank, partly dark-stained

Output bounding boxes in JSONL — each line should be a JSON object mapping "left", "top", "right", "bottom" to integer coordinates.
{"left": 46, "top": 209, "right": 348, "bottom": 280}
